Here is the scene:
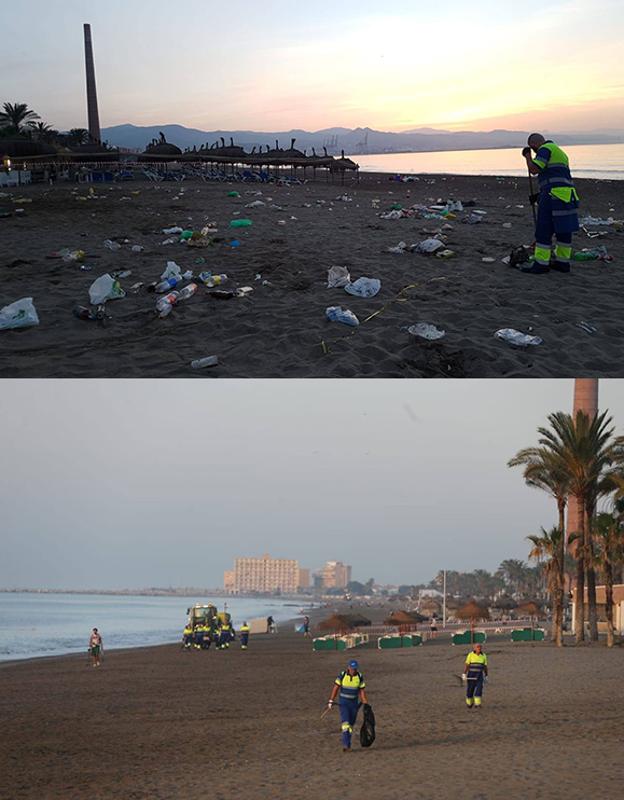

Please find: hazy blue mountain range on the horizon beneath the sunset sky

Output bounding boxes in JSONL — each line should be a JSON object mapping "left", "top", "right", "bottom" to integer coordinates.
{"left": 102, "top": 124, "right": 624, "bottom": 155}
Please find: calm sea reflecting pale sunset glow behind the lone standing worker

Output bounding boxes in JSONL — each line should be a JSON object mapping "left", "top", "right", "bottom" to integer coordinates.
{"left": 352, "top": 144, "right": 624, "bottom": 180}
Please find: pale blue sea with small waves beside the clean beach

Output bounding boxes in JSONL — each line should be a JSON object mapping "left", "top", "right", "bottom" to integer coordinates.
{"left": 0, "top": 593, "right": 300, "bottom": 661}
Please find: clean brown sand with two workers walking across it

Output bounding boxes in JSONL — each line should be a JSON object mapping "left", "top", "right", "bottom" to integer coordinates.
{"left": 0, "top": 616, "right": 624, "bottom": 800}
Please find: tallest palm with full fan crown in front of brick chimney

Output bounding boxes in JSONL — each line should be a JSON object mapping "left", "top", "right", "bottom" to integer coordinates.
{"left": 538, "top": 411, "right": 624, "bottom": 642}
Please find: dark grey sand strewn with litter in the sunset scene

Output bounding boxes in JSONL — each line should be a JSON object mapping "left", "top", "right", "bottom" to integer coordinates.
{"left": 0, "top": 174, "right": 624, "bottom": 378}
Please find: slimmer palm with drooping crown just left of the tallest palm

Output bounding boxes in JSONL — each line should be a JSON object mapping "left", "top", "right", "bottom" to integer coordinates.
{"left": 507, "top": 447, "right": 572, "bottom": 647}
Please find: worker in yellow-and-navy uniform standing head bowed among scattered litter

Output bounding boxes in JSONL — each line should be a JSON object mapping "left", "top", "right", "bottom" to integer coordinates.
{"left": 521, "top": 133, "right": 580, "bottom": 275}
